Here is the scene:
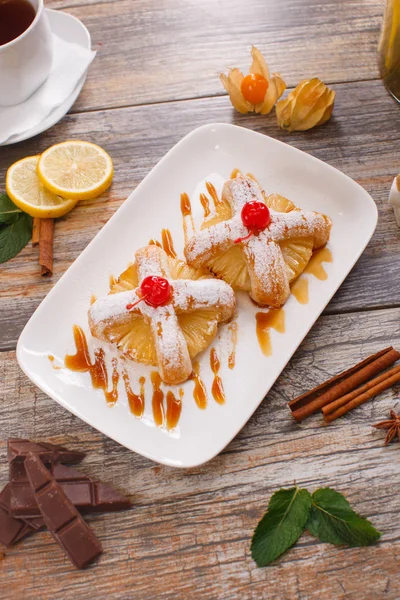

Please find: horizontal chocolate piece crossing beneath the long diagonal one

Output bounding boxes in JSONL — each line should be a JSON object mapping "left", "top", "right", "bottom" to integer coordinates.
{"left": 10, "top": 463, "right": 132, "bottom": 518}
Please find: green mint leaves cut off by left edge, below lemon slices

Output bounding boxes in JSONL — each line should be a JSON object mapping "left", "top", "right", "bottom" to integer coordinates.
{"left": 0, "top": 194, "right": 32, "bottom": 263}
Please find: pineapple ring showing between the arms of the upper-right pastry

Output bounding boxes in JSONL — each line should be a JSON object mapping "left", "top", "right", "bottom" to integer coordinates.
{"left": 198, "top": 192, "right": 313, "bottom": 292}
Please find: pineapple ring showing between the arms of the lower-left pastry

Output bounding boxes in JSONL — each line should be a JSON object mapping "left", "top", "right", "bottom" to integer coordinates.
{"left": 105, "top": 257, "right": 222, "bottom": 366}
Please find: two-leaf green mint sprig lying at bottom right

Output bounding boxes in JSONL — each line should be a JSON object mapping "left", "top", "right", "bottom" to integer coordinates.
{"left": 251, "top": 486, "right": 381, "bottom": 567}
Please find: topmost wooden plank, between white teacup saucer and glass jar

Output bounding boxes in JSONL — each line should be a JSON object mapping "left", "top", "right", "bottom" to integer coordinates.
{"left": 43, "top": 0, "right": 384, "bottom": 111}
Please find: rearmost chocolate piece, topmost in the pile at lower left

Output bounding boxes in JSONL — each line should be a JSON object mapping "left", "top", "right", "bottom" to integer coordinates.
{"left": 7, "top": 438, "right": 85, "bottom": 465}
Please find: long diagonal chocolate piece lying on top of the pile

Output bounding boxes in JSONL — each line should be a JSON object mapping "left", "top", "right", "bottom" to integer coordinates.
{"left": 25, "top": 453, "right": 103, "bottom": 569}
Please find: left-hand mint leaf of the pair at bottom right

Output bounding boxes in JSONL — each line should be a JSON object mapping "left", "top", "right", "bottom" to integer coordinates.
{"left": 251, "top": 486, "right": 312, "bottom": 567}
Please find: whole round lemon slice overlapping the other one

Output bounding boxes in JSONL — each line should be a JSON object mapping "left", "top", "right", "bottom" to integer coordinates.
{"left": 38, "top": 140, "right": 114, "bottom": 200}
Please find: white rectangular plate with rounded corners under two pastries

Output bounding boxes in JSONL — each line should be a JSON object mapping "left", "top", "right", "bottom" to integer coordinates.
{"left": 17, "top": 124, "right": 377, "bottom": 467}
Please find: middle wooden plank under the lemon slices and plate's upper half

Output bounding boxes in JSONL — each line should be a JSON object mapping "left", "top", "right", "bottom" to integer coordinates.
{"left": 0, "top": 82, "right": 400, "bottom": 349}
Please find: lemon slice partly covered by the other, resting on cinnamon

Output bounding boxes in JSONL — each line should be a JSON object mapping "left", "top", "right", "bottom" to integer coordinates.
{"left": 6, "top": 154, "right": 77, "bottom": 219}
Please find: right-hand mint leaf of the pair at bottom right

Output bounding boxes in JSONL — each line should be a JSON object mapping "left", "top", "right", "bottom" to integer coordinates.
{"left": 306, "top": 488, "right": 381, "bottom": 546}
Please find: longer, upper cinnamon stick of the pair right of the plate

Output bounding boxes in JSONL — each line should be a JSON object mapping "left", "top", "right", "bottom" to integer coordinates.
{"left": 289, "top": 347, "right": 400, "bottom": 422}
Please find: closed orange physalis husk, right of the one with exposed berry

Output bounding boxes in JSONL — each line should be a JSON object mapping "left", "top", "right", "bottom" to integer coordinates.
{"left": 276, "top": 77, "right": 335, "bottom": 131}
